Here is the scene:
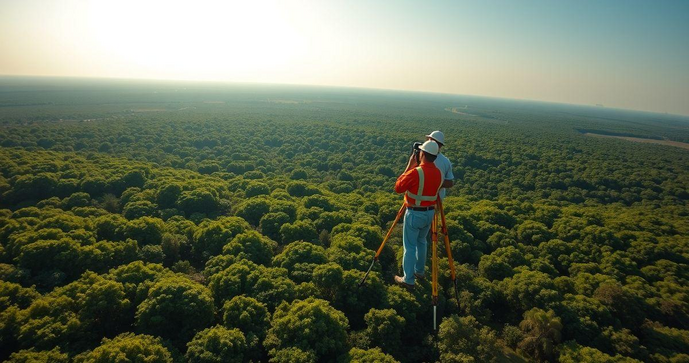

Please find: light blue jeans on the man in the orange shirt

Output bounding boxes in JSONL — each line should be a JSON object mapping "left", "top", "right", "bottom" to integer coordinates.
{"left": 402, "top": 209, "right": 434, "bottom": 285}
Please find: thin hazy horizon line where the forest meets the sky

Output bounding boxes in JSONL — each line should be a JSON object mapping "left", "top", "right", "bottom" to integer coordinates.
{"left": 0, "top": 74, "right": 689, "bottom": 118}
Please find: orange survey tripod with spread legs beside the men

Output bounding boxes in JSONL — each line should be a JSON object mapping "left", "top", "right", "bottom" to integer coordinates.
{"left": 359, "top": 197, "right": 459, "bottom": 330}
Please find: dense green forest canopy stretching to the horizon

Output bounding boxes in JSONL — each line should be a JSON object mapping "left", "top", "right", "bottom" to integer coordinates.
{"left": 0, "top": 77, "right": 689, "bottom": 363}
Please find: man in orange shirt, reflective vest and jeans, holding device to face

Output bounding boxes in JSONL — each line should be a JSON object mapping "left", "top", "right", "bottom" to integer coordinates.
{"left": 395, "top": 140, "right": 442, "bottom": 288}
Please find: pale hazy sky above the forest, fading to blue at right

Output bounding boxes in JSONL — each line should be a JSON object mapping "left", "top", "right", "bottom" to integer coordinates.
{"left": 0, "top": 0, "right": 689, "bottom": 115}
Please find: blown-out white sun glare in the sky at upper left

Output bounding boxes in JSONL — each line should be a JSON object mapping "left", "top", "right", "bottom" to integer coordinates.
{"left": 88, "top": 0, "right": 304, "bottom": 79}
